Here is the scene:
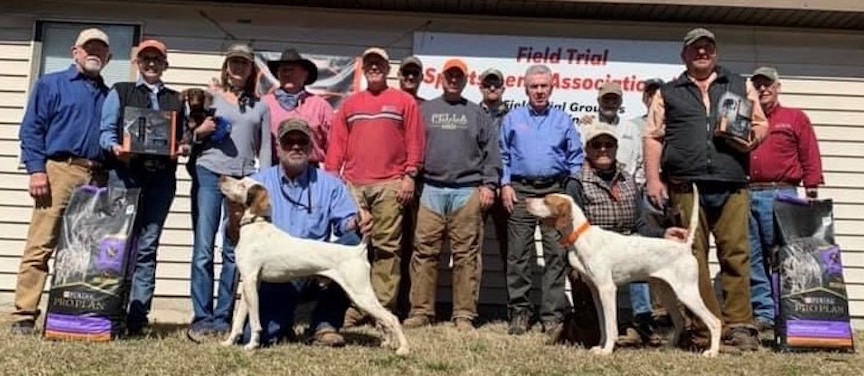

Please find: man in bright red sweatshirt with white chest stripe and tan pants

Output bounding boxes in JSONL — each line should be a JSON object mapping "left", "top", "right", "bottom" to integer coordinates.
{"left": 324, "top": 47, "right": 426, "bottom": 327}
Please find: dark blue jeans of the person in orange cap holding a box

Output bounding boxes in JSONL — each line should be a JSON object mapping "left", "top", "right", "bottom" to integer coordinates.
{"left": 108, "top": 165, "right": 177, "bottom": 331}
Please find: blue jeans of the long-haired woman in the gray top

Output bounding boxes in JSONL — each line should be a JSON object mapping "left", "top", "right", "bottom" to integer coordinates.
{"left": 190, "top": 166, "right": 237, "bottom": 331}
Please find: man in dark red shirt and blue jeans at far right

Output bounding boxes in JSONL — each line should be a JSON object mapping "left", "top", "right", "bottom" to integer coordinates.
{"left": 750, "top": 67, "right": 824, "bottom": 331}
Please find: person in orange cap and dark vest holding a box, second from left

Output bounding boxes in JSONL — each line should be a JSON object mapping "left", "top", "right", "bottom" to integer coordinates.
{"left": 99, "top": 39, "right": 183, "bottom": 335}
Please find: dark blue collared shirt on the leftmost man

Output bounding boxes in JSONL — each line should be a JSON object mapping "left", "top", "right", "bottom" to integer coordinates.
{"left": 18, "top": 64, "right": 108, "bottom": 174}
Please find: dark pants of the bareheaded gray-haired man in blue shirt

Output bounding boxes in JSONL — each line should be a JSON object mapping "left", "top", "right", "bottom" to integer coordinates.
{"left": 507, "top": 182, "right": 569, "bottom": 322}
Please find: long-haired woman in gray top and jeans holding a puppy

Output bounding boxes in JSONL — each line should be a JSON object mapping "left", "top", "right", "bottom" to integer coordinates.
{"left": 188, "top": 44, "right": 273, "bottom": 341}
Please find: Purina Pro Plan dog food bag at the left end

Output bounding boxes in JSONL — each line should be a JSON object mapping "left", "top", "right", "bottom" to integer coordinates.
{"left": 43, "top": 185, "right": 139, "bottom": 341}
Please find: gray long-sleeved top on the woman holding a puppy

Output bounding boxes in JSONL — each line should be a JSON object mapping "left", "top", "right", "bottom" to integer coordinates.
{"left": 197, "top": 91, "right": 273, "bottom": 176}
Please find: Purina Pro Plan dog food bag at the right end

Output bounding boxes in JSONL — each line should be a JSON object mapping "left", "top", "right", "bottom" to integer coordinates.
{"left": 773, "top": 197, "right": 855, "bottom": 352}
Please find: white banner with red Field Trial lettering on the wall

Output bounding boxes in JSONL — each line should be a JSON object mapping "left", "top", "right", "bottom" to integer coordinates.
{"left": 414, "top": 32, "right": 684, "bottom": 119}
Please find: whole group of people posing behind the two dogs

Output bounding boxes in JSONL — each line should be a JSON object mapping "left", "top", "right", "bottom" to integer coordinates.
{"left": 12, "top": 28, "right": 823, "bottom": 351}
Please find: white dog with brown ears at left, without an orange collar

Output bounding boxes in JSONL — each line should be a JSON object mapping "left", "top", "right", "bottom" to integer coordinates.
{"left": 219, "top": 177, "right": 409, "bottom": 355}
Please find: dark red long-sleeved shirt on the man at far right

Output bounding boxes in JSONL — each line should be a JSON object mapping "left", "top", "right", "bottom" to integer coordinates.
{"left": 750, "top": 105, "right": 825, "bottom": 188}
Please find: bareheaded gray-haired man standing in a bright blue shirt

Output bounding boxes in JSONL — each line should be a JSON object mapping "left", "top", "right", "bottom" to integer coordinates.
{"left": 500, "top": 65, "right": 585, "bottom": 338}
